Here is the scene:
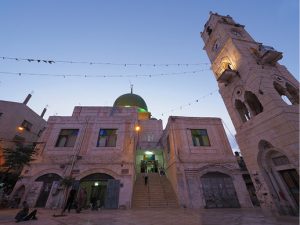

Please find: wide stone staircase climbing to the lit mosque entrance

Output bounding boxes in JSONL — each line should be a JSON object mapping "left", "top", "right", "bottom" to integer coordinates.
{"left": 132, "top": 173, "right": 178, "bottom": 208}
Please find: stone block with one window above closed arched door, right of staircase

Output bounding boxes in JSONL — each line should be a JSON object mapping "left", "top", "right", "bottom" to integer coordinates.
{"left": 163, "top": 116, "right": 252, "bottom": 208}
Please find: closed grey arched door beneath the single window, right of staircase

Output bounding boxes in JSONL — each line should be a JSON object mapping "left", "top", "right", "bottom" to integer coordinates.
{"left": 201, "top": 172, "right": 240, "bottom": 208}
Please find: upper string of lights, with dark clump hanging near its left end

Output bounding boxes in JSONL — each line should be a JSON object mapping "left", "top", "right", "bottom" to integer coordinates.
{"left": 0, "top": 56, "right": 210, "bottom": 67}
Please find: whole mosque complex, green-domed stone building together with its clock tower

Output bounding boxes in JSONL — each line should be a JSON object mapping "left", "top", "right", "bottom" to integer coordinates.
{"left": 12, "top": 13, "right": 299, "bottom": 214}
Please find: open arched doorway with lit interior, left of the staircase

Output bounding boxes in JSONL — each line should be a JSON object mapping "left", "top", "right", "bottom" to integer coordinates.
{"left": 80, "top": 173, "right": 120, "bottom": 209}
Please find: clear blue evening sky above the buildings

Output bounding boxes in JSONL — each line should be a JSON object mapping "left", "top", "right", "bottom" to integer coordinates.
{"left": 0, "top": 0, "right": 299, "bottom": 151}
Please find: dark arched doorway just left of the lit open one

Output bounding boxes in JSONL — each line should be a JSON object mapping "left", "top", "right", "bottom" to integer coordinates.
{"left": 35, "top": 173, "right": 62, "bottom": 207}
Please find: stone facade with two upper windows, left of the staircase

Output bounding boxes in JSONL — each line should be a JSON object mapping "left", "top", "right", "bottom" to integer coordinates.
{"left": 15, "top": 107, "right": 137, "bottom": 207}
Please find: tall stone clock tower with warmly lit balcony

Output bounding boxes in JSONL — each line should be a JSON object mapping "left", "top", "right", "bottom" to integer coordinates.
{"left": 201, "top": 13, "right": 299, "bottom": 215}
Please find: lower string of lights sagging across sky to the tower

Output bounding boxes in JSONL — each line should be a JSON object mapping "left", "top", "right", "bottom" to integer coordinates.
{"left": 0, "top": 69, "right": 210, "bottom": 78}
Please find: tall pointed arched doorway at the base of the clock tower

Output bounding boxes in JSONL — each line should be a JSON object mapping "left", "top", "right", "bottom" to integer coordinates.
{"left": 258, "top": 140, "right": 299, "bottom": 215}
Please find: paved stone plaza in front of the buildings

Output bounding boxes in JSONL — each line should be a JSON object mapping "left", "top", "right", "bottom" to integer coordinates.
{"left": 0, "top": 208, "right": 298, "bottom": 225}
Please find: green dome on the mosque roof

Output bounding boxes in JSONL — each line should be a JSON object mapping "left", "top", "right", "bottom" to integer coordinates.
{"left": 114, "top": 93, "right": 148, "bottom": 112}
